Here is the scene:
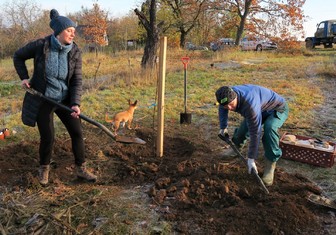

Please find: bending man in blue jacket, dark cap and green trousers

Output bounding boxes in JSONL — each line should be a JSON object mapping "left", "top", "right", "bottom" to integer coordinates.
{"left": 216, "top": 84, "right": 288, "bottom": 186}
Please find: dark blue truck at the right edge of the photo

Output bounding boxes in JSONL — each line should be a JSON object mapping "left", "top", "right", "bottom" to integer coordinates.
{"left": 305, "top": 20, "right": 336, "bottom": 49}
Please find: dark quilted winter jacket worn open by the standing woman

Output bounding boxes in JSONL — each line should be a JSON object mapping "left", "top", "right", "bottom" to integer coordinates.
{"left": 13, "top": 36, "right": 82, "bottom": 126}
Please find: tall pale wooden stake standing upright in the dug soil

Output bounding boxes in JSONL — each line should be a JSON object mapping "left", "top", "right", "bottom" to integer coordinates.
{"left": 156, "top": 37, "right": 167, "bottom": 157}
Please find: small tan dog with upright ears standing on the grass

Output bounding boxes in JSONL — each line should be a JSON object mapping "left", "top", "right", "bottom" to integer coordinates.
{"left": 105, "top": 100, "right": 138, "bottom": 135}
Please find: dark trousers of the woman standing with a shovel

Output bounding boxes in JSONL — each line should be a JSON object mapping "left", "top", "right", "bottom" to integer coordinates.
{"left": 37, "top": 102, "right": 85, "bottom": 166}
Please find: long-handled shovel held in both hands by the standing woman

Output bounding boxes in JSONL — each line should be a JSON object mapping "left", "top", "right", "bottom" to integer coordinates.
{"left": 27, "top": 88, "right": 146, "bottom": 144}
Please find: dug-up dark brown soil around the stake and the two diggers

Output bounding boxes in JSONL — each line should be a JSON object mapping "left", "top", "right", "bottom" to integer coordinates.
{"left": 0, "top": 126, "right": 335, "bottom": 235}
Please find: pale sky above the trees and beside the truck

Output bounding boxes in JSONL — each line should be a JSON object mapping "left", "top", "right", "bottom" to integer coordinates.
{"left": 33, "top": 0, "right": 336, "bottom": 37}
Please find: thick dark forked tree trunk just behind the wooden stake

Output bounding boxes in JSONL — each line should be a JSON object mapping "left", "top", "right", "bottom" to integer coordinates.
{"left": 134, "top": 0, "right": 163, "bottom": 69}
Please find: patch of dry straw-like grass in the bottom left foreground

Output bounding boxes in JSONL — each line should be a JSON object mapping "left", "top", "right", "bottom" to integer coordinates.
{"left": 0, "top": 182, "right": 171, "bottom": 234}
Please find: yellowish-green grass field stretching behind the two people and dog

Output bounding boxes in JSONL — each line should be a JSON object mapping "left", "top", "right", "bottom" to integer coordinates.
{"left": 0, "top": 46, "right": 336, "bottom": 140}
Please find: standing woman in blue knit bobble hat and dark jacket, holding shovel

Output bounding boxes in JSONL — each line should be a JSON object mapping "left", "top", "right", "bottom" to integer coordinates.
{"left": 13, "top": 9, "right": 97, "bottom": 185}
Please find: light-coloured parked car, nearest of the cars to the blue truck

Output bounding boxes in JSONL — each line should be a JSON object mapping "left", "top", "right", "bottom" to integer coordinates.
{"left": 240, "top": 37, "right": 278, "bottom": 51}
